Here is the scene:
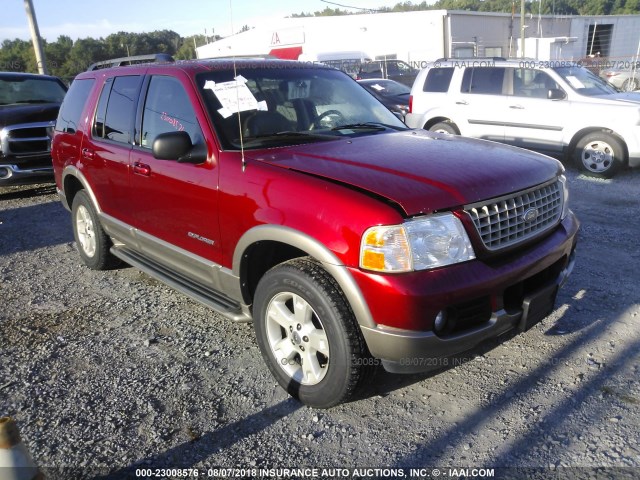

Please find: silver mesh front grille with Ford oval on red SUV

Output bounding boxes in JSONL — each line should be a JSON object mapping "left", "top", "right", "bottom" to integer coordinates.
{"left": 465, "top": 180, "right": 564, "bottom": 251}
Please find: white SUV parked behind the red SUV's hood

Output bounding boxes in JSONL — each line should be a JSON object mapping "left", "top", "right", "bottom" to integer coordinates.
{"left": 406, "top": 59, "right": 640, "bottom": 177}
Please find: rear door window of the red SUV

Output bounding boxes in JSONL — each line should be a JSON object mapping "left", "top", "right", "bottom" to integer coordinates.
{"left": 93, "top": 75, "right": 141, "bottom": 143}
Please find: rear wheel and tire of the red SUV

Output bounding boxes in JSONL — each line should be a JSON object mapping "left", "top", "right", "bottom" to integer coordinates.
{"left": 71, "top": 190, "right": 120, "bottom": 270}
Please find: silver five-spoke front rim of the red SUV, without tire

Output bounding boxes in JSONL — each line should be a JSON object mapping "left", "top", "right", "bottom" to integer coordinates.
{"left": 266, "top": 292, "right": 329, "bottom": 385}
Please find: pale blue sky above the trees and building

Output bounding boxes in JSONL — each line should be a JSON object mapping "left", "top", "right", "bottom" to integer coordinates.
{"left": 0, "top": 0, "right": 419, "bottom": 42}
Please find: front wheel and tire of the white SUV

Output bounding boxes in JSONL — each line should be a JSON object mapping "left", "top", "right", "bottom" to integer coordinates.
{"left": 573, "top": 132, "right": 625, "bottom": 178}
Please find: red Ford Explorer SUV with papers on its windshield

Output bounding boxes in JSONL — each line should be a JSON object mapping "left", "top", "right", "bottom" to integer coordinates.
{"left": 53, "top": 59, "right": 578, "bottom": 408}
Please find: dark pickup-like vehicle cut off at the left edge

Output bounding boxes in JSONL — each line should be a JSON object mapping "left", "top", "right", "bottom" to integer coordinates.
{"left": 0, "top": 72, "right": 67, "bottom": 187}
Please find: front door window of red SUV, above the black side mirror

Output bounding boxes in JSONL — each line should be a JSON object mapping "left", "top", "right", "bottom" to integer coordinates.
{"left": 140, "top": 75, "right": 202, "bottom": 148}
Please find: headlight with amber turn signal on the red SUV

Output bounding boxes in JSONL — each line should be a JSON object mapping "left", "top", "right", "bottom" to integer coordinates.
{"left": 360, "top": 213, "right": 475, "bottom": 273}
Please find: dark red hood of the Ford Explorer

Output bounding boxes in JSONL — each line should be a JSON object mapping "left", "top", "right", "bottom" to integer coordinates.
{"left": 247, "top": 130, "right": 562, "bottom": 216}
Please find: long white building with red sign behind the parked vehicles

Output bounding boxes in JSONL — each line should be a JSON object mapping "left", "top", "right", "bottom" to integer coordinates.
{"left": 197, "top": 10, "right": 640, "bottom": 66}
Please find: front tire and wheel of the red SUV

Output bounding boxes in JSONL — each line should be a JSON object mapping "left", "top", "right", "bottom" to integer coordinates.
{"left": 253, "top": 258, "right": 373, "bottom": 408}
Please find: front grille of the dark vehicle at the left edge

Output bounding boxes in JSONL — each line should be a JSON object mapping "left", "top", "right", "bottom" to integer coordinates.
{"left": 0, "top": 122, "right": 54, "bottom": 158}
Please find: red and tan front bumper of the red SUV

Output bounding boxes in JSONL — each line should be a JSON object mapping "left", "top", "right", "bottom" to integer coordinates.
{"left": 359, "top": 213, "right": 579, "bottom": 373}
